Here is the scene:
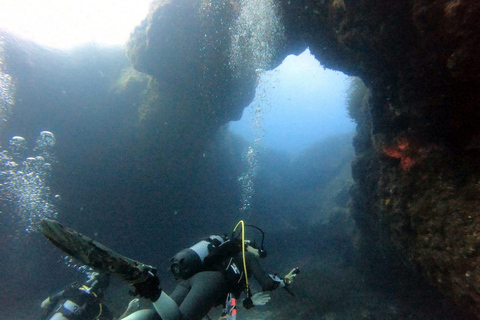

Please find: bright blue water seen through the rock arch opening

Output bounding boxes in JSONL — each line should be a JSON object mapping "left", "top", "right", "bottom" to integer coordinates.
{"left": 230, "top": 50, "right": 355, "bottom": 154}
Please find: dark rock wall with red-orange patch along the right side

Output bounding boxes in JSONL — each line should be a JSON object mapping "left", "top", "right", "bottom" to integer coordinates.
{"left": 282, "top": 0, "right": 480, "bottom": 316}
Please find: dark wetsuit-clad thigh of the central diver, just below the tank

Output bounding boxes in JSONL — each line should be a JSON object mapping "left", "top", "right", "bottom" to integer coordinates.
{"left": 180, "top": 271, "right": 227, "bottom": 320}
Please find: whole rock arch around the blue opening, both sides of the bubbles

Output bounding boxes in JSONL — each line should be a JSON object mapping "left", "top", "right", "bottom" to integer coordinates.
{"left": 129, "top": 0, "right": 480, "bottom": 317}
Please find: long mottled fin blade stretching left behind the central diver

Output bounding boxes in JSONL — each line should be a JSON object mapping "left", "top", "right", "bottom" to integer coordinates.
{"left": 40, "top": 219, "right": 158, "bottom": 284}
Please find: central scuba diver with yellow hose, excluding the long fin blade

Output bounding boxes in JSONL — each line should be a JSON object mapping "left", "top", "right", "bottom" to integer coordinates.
{"left": 125, "top": 221, "right": 300, "bottom": 320}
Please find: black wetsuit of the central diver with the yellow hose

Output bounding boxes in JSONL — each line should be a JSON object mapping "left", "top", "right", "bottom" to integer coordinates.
{"left": 125, "top": 252, "right": 279, "bottom": 320}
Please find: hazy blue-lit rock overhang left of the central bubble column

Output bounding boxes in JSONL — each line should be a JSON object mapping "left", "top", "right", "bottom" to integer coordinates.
{"left": 129, "top": 0, "right": 256, "bottom": 123}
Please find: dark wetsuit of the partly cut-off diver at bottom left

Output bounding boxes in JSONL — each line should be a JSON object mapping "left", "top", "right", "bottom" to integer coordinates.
{"left": 42, "top": 283, "right": 114, "bottom": 320}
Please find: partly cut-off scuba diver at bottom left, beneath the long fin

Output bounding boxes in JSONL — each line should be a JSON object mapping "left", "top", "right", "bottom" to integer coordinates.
{"left": 41, "top": 272, "right": 139, "bottom": 320}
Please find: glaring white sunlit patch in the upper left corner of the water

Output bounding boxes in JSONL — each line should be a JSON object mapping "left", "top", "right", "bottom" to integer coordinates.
{"left": 0, "top": 0, "right": 151, "bottom": 49}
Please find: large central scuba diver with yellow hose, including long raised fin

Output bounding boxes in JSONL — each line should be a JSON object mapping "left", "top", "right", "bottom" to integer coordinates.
{"left": 40, "top": 219, "right": 300, "bottom": 320}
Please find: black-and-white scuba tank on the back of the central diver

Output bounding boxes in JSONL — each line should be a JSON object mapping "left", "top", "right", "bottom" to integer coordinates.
{"left": 170, "top": 235, "right": 241, "bottom": 279}
